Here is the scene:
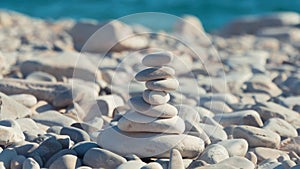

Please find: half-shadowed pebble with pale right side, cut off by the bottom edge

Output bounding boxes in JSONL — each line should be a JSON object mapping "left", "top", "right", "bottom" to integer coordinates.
{"left": 49, "top": 154, "right": 81, "bottom": 169}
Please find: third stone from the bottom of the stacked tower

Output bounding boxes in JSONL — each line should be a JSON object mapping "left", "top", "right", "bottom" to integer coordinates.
{"left": 128, "top": 96, "right": 178, "bottom": 118}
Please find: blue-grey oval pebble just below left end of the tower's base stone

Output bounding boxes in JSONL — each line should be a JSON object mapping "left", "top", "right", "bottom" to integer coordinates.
{"left": 83, "top": 147, "right": 127, "bottom": 168}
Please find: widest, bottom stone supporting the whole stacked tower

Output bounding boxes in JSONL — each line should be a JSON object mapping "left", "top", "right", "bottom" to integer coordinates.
{"left": 97, "top": 126, "right": 204, "bottom": 158}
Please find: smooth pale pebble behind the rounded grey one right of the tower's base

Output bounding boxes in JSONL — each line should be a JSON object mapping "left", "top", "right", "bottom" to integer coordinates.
{"left": 217, "top": 139, "right": 248, "bottom": 157}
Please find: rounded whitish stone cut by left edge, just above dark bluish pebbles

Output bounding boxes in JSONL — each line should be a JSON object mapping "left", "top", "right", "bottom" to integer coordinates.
{"left": 0, "top": 120, "right": 25, "bottom": 146}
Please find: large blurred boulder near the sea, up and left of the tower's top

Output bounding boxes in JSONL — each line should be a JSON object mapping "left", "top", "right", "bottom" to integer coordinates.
{"left": 69, "top": 21, "right": 148, "bottom": 53}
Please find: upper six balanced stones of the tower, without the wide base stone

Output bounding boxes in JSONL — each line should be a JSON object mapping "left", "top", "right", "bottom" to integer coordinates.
{"left": 118, "top": 50, "right": 185, "bottom": 134}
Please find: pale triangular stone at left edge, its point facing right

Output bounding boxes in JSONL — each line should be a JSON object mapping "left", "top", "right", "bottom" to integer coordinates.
{"left": 0, "top": 92, "right": 32, "bottom": 120}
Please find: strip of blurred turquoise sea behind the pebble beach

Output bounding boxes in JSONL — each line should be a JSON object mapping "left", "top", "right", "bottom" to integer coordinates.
{"left": 0, "top": 0, "right": 300, "bottom": 31}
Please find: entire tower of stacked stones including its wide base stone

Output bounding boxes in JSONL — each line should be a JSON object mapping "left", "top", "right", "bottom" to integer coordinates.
{"left": 97, "top": 52, "right": 204, "bottom": 158}
